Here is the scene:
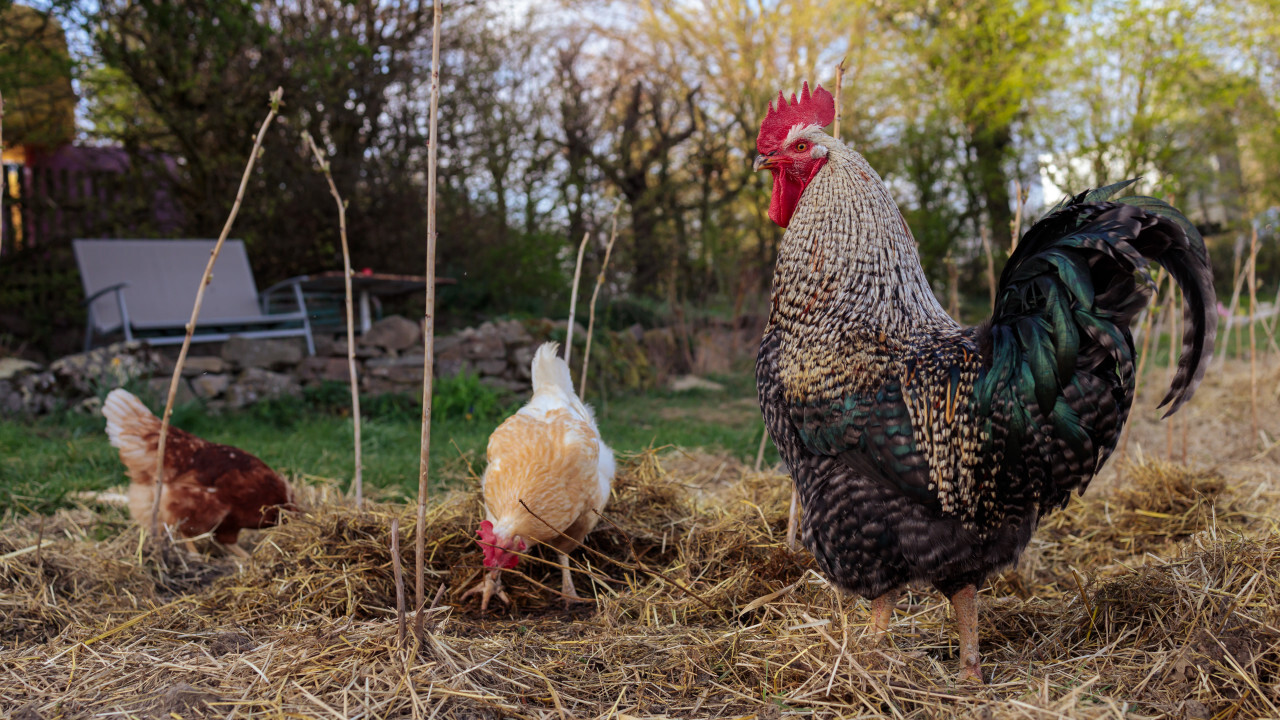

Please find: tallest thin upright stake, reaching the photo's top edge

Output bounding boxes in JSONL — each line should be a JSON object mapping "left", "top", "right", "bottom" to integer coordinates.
{"left": 413, "top": 0, "right": 440, "bottom": 609}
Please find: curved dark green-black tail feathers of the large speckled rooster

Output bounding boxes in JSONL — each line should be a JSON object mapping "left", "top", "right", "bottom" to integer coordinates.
{"left": 992, "top": 179, "right": 1217, "bottom": 418}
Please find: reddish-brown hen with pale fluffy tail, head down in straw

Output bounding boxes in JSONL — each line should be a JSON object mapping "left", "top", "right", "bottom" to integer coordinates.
{"left": 102, "top": 388, "right": 294, "bottom": 559}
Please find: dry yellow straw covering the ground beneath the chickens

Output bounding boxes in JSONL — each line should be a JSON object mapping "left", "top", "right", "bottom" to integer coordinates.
{"left": 0, "top": 363, "right": 1280, "bottom": 720}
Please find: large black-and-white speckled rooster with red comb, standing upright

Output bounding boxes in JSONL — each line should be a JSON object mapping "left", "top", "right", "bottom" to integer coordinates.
{"left": 754, "top": 83, "right": 1217, "bottom": 683}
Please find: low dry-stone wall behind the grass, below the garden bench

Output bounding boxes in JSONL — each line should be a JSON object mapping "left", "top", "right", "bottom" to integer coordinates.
{"left": 0, "top": 315, "right": 759, "bottom": 415}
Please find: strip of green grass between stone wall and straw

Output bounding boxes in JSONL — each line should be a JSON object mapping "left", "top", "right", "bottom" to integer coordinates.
{"left": 0, "top": 373, "right": 777, "bottom": 518}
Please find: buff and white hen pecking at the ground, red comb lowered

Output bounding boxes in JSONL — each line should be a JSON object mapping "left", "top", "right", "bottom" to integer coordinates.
{"left": 462, "top": 342, "right": 614, "bottom": 612}
